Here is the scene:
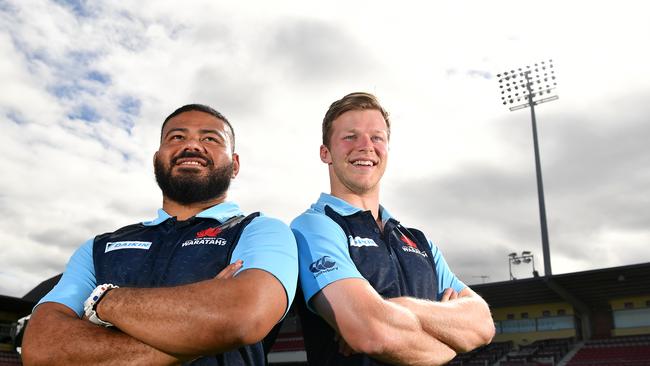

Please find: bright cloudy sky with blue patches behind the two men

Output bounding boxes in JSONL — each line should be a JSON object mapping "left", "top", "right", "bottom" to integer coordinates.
{"left": 0, "top": 0, "right": 650, "bottom": 296}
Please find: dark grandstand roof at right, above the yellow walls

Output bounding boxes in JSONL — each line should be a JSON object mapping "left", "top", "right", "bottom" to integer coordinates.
{"left": 471, "top": 263, "right": 650, "bottom": 308}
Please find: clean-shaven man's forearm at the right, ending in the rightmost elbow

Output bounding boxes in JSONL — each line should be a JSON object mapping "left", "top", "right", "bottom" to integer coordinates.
{"left": 389, "top": 294, "right": 494, "bottom": 352}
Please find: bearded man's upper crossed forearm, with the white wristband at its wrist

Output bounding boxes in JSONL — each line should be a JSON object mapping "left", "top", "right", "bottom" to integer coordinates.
{"left": 97, "top": 269, "right": 286, "bottom": 355}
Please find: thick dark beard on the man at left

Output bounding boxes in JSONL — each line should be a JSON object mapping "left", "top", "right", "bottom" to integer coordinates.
{"left": 154, "top": 152, "right": 233, "bottom": 205}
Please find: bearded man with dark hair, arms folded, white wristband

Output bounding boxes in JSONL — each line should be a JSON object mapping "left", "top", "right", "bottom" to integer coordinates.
{"left": 23, "top": 104, "right": 298, "bottom": 365}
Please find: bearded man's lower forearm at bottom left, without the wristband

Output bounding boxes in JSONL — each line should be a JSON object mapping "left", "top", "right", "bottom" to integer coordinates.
{"left": 22, "top": 303, "right": 181, "bottom": 365}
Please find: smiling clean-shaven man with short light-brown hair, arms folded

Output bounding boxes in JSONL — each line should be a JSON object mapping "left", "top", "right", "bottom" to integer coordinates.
{"left": 291, "top": 93, "right": 494, "bottom": 365}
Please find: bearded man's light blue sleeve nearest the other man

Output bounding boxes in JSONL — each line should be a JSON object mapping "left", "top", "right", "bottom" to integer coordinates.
{"left": 231, "top": 216, "right": 298, "bottom": 314}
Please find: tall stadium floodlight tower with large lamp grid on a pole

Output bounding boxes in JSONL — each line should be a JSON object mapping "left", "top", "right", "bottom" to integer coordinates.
{"left": 497, "top": 60, "right": 558, "bottom": 276}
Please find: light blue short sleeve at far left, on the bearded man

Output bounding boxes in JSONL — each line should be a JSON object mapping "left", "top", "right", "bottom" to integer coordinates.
{"left": 36, "top": 239, "right": 97, "bottom": 317}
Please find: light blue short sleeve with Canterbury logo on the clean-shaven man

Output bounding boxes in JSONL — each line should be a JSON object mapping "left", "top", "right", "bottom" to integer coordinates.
{"left": 291, "top": 211, "right": 364, "bottom": 309}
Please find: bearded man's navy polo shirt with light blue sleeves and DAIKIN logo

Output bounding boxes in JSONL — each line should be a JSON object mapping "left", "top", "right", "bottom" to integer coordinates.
{"left": 39, "top": 202, "right": 298, "bottom": 366}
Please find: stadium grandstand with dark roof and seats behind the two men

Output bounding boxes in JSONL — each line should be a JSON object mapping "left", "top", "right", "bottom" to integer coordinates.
{"left": 0, "top": 263, "right": 650, "bottom": 366}
